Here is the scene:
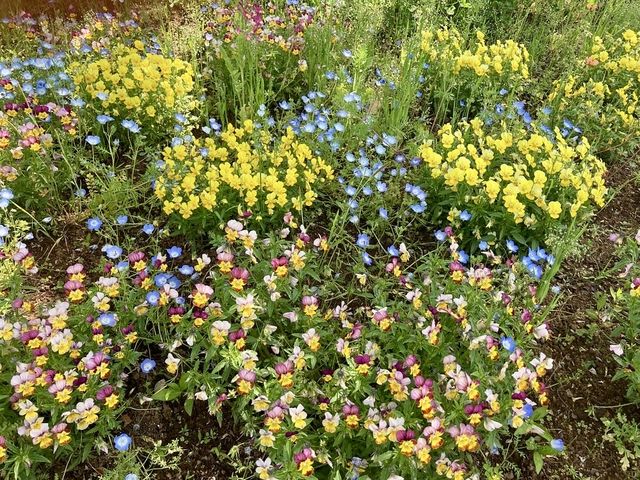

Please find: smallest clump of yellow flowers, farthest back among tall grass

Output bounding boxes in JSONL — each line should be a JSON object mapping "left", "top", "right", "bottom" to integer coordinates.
{"left": 421, "top": 28, "right": 529, "bottom": 88}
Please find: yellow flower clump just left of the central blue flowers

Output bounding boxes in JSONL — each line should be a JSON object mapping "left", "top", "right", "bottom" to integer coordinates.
{"left": 155, "top": 120, "right": 334, "bottom": 223}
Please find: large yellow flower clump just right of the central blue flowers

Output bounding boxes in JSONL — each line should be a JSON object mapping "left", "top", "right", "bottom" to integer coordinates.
{"left": 420, "top": 118, "right": 607, "bottom": 226}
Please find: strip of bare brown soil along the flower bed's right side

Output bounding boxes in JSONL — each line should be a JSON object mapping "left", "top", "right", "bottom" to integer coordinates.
{"left": 517, "top": 159, "right": 640, "bottom": 480}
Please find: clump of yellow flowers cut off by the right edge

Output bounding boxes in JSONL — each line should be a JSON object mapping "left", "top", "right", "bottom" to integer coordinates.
{"left": 550, "top": 30, "right": 640, "bottom": 153}
